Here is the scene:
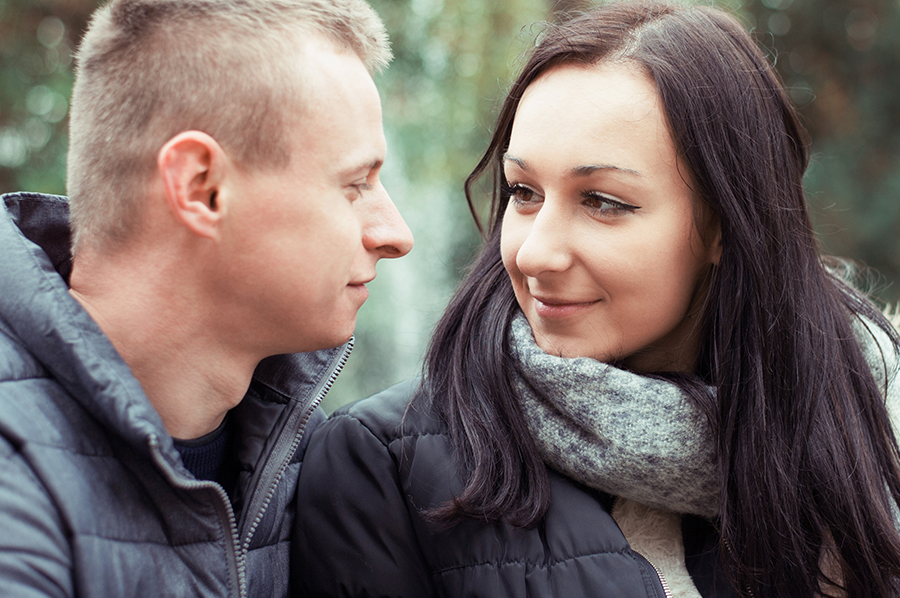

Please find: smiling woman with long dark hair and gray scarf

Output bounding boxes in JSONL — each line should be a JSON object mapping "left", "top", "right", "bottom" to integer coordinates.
{"left": 292, "top": 3, "right": 900, "bottom": 598}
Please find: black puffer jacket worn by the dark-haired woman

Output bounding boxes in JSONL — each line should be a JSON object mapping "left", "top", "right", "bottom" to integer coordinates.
{"left": 291, "top": 381, "right": 731, "bottom": 598}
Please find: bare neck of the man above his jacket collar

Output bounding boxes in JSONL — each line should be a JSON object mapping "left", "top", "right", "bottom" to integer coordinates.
{"left": 70, "top": 244, "right": 259, "bottom": 439}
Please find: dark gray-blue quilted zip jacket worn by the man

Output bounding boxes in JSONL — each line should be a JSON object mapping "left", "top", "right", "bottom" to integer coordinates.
{"left": 0, "top": 194, "right": 349, "bottom": 598}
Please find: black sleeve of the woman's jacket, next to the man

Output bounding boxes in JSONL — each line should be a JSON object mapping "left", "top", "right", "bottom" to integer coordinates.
{"left": 291, "top": 414, "right": 434, "bottom": 598}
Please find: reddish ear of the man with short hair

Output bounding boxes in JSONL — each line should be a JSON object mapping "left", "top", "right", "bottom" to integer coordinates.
{"left": 157, "top": 131, "right": 228, "bottom": 239}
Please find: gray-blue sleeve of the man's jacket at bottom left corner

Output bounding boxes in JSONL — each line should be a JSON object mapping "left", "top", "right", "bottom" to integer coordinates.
{"left": 0, "top": 438, "right": 74, "bottom": 598}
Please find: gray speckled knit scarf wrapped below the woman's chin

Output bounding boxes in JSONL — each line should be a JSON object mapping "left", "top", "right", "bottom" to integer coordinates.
{"left": 510, "top": 313, "right": 718, "bottom": 517}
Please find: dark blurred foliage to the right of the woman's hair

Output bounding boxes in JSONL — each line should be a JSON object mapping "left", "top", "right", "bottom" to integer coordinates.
{"left": 748, "top": 0, "right": 900, "bottom": 302}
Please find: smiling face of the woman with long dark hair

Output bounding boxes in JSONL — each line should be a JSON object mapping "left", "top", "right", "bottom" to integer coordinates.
{"left": 501, "top": 59, "right": 718, "bottom": 371}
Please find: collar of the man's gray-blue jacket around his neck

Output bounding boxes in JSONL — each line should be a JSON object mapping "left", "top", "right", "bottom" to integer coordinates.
{"left": 0, "top": 193, "right": 346, "bottom": 466}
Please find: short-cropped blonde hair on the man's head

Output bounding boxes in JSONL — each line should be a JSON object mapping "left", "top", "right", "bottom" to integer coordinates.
{"left": 67, "top": 0, "right": 391, "bottom": 249}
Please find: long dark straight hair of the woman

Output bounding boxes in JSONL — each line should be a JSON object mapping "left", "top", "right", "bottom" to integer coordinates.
{"left": 425, "top": 2, "right": 900, "bottom": 598}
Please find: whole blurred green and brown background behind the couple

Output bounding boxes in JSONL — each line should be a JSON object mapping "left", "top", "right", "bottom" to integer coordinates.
{"left": 0, "top": 0, "right": 900, "bottom": 411}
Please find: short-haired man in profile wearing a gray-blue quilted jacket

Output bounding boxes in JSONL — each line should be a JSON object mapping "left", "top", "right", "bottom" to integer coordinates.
{"left": 0, "top": 0, "right": 412, "bottom": 598}
